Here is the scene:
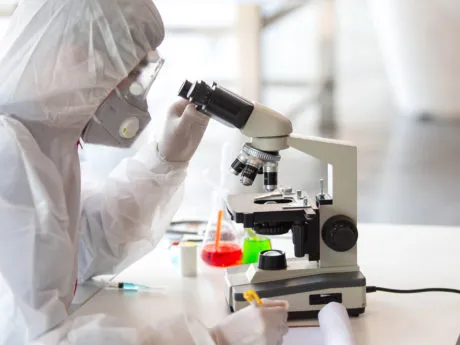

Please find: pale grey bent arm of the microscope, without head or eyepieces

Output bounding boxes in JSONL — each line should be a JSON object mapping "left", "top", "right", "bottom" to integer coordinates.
{"left": 286, "top": 134, "right": 357, "bottom": 221}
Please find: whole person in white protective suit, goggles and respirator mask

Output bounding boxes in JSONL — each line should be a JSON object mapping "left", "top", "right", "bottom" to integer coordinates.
{"left": 0, "top": 0, "right": 358, "bottom": 345}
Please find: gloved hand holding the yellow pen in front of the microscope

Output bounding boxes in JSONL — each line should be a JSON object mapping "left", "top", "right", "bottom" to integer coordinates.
{"left": 211, "top": 300, "right": 289, "bottom": 345}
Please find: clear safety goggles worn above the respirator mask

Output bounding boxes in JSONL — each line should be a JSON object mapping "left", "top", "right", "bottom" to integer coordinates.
{"left": 127, "top": 50, "right": 164, "bottom": 99}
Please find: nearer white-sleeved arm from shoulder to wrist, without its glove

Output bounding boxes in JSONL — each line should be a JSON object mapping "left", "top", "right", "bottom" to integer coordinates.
{"left": 0, "top": 115, "right": 213, "bottom": 345}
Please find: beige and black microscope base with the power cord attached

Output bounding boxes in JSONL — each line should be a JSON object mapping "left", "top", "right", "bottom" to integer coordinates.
{"left": 225, "top": 271, "right": 366, "bottom": 320}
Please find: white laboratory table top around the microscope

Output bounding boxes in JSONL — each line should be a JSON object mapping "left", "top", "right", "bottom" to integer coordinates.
{"left": 74, "top": 224, "right": 460, "bottom": 345}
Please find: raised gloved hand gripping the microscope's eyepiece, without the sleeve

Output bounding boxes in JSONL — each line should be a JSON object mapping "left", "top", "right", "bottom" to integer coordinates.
{"left": 158, "top": 99, "right": 209, "bottom": 162}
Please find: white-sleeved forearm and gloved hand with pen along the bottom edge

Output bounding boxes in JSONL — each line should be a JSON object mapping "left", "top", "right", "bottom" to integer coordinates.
{"left": 32, "top": 301, "right": 288, "bottom": 345}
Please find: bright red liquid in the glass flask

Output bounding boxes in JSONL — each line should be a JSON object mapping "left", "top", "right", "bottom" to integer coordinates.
{"left": 201, "top": 242, "right": 243, "bottom": 267}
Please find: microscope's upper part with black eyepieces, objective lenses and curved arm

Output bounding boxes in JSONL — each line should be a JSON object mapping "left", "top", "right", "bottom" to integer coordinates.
{"left": 179, "top": 81, "right": 357, "bottom": 207}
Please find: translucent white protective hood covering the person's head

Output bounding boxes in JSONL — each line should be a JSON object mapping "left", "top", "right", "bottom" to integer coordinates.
{"left": 0, "top": 0, "right": 164, "bottom": 135}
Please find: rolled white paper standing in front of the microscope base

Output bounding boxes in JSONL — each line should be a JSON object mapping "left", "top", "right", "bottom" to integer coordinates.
{"left": 318, "top": 302, "right": 356, "bottom": 345}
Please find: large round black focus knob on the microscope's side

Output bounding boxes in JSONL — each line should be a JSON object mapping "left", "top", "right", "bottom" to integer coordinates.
{"left": 322, "top": 215, "right": 358, "bottom": 252}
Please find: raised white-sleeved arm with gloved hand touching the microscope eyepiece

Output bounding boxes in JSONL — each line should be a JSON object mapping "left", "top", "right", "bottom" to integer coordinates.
{"left": 78, "top": 100, "right": 209, "bottom": 281}
